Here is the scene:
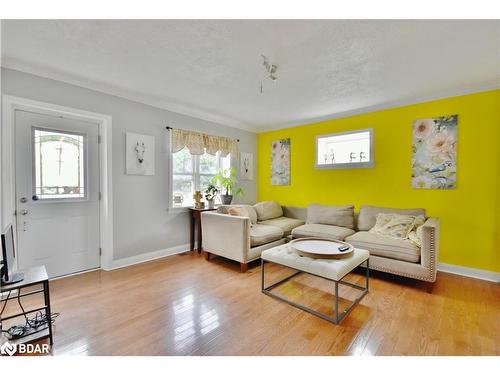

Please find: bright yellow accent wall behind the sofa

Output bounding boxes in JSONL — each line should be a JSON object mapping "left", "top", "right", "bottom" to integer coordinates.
{"left": 257, "top": 90, "right": 500, "bottom": 272}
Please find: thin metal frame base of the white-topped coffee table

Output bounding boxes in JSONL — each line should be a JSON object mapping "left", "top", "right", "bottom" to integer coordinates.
{"left": 260, "top": 258, "right": 370, "bottom": 324}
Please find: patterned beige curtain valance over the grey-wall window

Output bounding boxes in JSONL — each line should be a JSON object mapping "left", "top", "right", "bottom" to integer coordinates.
{"left": 171, "top": 129, "right": 238, "bottom": 156}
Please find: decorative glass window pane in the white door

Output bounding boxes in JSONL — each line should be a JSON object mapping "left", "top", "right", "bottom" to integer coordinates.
{"left": 32, "top": 128, "right": 87, "bottom": 200}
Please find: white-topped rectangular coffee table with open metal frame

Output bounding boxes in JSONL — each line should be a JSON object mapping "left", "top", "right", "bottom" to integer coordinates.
{"left": 261, "top": 244, "right": 370, "bottom": 324}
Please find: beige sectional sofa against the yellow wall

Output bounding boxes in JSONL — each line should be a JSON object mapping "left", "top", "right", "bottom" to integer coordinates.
{"left": 202, "top": 202, "right": 439, "bottom": 283}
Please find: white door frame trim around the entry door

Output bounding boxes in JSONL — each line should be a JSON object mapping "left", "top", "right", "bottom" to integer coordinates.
{"left": 0, "top": 95, "right": 113, "bottom": 271}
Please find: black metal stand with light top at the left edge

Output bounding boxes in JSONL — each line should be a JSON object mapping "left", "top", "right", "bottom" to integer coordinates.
{"left": 0, "top": 266, "right": 54, "bottom": 352}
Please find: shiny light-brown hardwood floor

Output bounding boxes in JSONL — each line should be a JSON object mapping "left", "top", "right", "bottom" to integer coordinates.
{"left": 2, "top": 253, "right": 500, "bottom": 355}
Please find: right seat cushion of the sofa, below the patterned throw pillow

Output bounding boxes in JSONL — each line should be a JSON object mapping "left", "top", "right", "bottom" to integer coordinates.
{"left": 345, "top": 232, "right": 420, "bottom": 263}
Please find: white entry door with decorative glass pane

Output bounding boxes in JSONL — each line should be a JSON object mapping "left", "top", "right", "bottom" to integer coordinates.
{"left": 15, "top": 110, "right": 100, "bottom": 277}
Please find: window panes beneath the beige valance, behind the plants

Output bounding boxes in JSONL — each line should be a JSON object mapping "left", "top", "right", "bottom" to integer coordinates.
{"left": 171, "top": 148, "right": 231, "bottom": 207}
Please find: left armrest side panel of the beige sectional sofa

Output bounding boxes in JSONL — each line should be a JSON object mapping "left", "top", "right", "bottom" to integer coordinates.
{"left": 201, "top": 212, "right": 250, "bottom": 263}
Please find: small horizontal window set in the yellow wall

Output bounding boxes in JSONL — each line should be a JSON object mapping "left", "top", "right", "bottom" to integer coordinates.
{"left": 316, "top": 129, "right": 374, "bottom": 169}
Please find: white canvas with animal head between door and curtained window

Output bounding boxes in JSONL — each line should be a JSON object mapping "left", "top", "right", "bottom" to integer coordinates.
{"left": 125, "top": 133, "right": 155, "bottom": 176}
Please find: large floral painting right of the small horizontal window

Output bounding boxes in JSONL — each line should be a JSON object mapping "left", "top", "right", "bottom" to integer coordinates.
{"left": 412, "top": 115, "right": 458, "bottom": 189}
